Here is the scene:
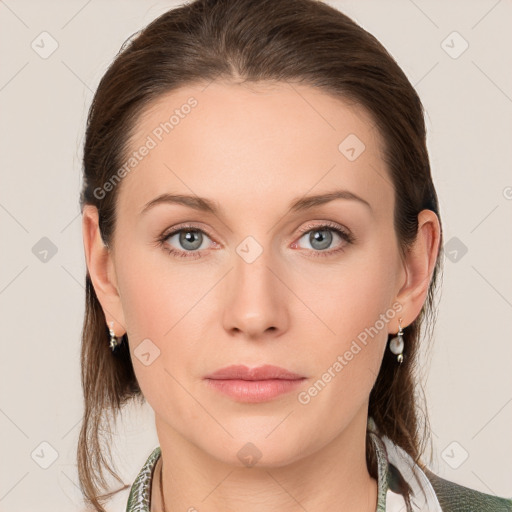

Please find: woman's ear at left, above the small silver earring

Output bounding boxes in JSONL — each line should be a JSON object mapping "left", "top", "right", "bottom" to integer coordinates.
{"left": 82, "top": 204, "right": 126, "bottom": 336}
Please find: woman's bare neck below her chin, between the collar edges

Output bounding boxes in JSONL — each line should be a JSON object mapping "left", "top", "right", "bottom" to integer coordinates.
{"left": 151, "top": 412, "right": 377, "bottom": 512}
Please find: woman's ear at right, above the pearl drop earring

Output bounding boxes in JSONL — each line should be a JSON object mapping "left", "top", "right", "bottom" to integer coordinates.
{"left": 394, "top": 210, "right": 441, "bottom": 333}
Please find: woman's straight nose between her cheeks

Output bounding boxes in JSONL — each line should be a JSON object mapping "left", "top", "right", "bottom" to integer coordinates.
{"left": 223, "top": 242, "right": 292, "bottom": 340}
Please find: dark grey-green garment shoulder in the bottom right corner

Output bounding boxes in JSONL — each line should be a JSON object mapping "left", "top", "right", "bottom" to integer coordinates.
{"left": 424, "top": 469, "right": 512, "bottom": 512}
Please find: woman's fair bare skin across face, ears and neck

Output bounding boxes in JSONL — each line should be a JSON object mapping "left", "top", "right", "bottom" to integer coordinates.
{"left": 83, "top": 81, "right": 440, "bottom": 512}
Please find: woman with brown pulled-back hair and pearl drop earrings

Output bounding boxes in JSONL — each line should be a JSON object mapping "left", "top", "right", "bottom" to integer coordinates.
{"left": 78, "top": 0, "right": 512, "bottom": 512}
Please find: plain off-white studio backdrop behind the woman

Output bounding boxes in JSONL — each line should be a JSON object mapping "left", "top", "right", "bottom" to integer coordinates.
{"left": 0, "top": 0, "right": 512, "bottom": 512}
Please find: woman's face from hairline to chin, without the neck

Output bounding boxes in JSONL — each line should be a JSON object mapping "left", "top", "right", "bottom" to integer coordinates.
{"left": 96, "top": 82, "right": 418, "bottom": 465}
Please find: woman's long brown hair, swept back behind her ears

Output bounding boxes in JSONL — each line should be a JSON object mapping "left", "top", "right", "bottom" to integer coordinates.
{"left": 77, "top": 0, "right": 442, "bottom": 512}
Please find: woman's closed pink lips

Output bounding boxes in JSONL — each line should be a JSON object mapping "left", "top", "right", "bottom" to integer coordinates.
{"left": 205, "top": 365, "right": 306, "bottom": 403}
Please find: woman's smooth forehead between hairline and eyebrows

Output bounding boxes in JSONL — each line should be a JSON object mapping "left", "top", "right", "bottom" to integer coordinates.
{"left": 119, "top": 82, "right": 393, "bottom": 222}
